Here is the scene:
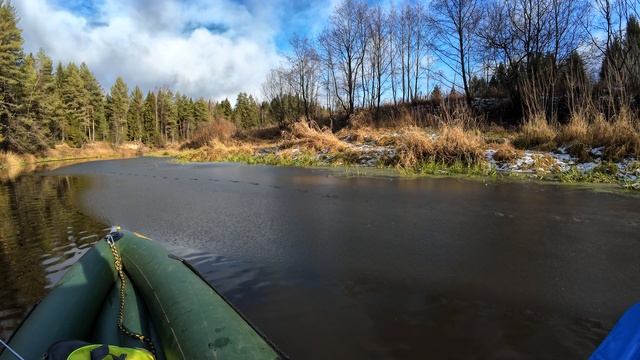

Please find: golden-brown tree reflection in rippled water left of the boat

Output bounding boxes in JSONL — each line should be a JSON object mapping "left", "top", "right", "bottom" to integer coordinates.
{"left": 0, "top": 175, "right": 104, "bottom": 338}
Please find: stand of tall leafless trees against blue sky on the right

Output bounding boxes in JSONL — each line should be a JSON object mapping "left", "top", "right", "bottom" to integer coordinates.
{"left": 264, "top": 0, "right": 640, "bottom": 126}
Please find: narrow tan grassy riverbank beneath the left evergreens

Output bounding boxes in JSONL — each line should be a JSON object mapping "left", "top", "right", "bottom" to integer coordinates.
{"left": 0, "top": 142, "right": 149, "bottom": 180}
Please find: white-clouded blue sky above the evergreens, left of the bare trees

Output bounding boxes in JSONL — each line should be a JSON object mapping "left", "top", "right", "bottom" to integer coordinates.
{"left": 13, "top": 0, "right": 336, "bottom": 99}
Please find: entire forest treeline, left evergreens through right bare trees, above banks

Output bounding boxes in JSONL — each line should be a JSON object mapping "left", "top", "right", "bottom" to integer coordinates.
{"left": 0, "top": 0, "right": 640, "bottom": 153}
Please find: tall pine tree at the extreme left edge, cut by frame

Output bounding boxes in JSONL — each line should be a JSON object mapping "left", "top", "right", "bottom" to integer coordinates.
{"left": 0, "top": 0, "right": 24, "bottom": 151}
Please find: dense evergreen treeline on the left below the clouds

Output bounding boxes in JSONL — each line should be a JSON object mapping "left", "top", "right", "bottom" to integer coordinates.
{"left": 0, "top": 0, "right": 268, "bottom": 153}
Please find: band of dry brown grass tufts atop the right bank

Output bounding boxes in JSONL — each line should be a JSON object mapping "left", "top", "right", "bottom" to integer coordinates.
{"left": 174, "top": 103, "right": 640, "bottom": 169}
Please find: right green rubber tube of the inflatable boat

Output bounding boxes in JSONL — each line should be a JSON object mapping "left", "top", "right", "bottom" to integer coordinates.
{"left": 118, "top": 231, "right": 279, "bottom": 360}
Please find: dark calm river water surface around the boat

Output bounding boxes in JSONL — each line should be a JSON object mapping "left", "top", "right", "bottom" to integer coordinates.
{"left": 0, "top": 158, "right": 640, "bottom": 359}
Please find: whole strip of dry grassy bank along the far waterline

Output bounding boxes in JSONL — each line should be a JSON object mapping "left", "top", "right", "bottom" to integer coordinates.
{"left": 5, "top": 110, "right": 640, "bottom": 190}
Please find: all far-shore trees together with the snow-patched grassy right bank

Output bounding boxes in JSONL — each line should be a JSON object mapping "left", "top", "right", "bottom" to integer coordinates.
{"left": 0, "top": 0, "right": 640, "bottom": 187}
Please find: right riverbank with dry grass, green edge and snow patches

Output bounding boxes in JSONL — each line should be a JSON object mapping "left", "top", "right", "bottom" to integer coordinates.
{"left": 171, "top": 122, "right": 640, "bottom": 190}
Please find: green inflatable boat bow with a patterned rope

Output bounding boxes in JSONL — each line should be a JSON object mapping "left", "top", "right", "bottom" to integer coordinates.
{"left": 0, "top": 228, "right": 286, "bottom": 360}
